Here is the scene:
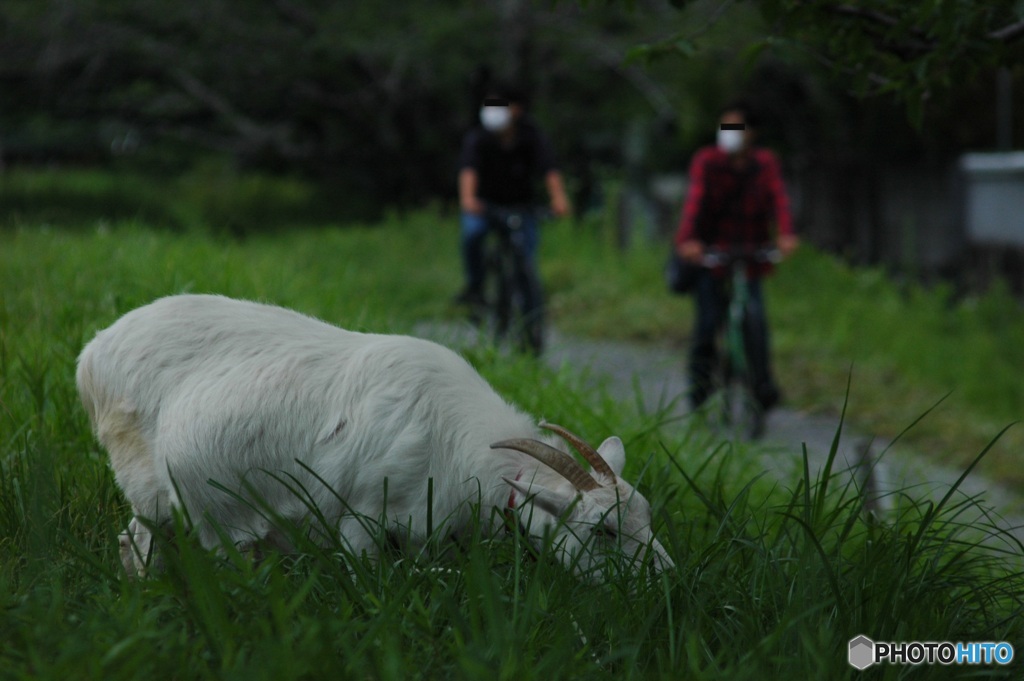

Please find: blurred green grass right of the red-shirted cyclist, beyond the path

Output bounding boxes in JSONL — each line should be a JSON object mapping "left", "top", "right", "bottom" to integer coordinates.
{"left": 771, "top": 250, "right": 1024, "bottom": 475}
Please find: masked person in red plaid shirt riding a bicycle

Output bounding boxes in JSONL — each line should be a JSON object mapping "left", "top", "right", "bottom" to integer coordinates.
{"left": 675, "top": 102, "right": 799, "bottom": 411}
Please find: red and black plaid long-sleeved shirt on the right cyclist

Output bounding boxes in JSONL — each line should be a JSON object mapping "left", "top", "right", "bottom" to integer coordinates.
{"left": 676, "top": 146, "right": 793, "bottom": 271}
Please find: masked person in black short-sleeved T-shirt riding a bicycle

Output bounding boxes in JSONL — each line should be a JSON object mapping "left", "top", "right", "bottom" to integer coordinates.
{"left": 456, "top": 87, "right": 569, "bottom": 313}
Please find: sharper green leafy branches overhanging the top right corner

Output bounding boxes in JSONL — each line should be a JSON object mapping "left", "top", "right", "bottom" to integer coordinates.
{"left": 638, "top": 0, "right": 1024, "bottom": 122}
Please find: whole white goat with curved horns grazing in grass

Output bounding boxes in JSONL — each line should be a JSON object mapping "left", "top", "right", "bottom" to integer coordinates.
{"left": 77, "top": 295, "right": 673, "bottom": 573}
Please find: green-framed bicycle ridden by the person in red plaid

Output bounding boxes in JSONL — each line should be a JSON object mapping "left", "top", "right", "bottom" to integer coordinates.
{"left": 700, "top": 248, "right": 782, "bottom": 439}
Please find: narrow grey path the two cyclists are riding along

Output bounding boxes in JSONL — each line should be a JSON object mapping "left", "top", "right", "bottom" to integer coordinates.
{"left": 415, "top": 323, "right": 1024, "bottom": 542}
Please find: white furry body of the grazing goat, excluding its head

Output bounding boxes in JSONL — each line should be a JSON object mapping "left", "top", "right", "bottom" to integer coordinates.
{"left": 77, "top": 295, "right": 530, "bottom": 534}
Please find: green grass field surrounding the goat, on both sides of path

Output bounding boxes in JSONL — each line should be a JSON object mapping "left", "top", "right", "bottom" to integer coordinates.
{"left": 0, "top": 173, "right": 1024, "bottom": 681}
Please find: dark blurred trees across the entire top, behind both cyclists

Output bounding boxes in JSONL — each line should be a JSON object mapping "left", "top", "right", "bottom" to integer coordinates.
{"left": 0, "top": 0, "right": 1024, "bottom": 225}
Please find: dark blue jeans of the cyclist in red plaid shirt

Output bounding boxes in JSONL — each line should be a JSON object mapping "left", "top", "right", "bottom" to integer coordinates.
{"left": 690, "top": 269, "right": 778, "bottom": 409}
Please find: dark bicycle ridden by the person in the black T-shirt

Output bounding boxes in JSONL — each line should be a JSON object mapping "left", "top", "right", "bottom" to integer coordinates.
{"left": 470, "top": 206, "right": 544, "bottom": 355}
